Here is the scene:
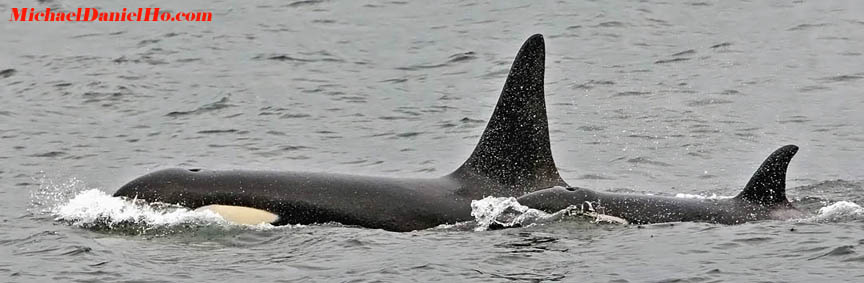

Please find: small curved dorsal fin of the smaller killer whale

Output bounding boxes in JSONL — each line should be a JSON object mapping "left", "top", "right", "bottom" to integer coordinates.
{"left": 736, "top": 145, "right": 798, "bottom": 205}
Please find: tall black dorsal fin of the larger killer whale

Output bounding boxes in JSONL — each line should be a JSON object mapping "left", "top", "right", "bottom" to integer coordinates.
{"left": 451, "top": 34, "right": 566, "bottom": 196}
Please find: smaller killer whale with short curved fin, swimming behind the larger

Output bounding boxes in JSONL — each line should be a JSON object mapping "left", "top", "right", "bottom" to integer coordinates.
{"left": 517, "top": 145, "right": 803, "bottom": 224}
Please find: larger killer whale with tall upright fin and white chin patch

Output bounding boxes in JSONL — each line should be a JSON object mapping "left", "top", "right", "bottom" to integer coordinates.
{"left": 114, "top": 34, "right": 567, "bottom": 231}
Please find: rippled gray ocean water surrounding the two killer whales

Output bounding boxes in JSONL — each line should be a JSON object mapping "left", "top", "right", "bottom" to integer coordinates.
{"left": 0, "top": 0, "right": 864, "bottom": 282}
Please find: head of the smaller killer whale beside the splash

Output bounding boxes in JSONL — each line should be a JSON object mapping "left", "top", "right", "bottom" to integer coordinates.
{"left": 517, "top": 186, "right": 597, "bottom": 211}
